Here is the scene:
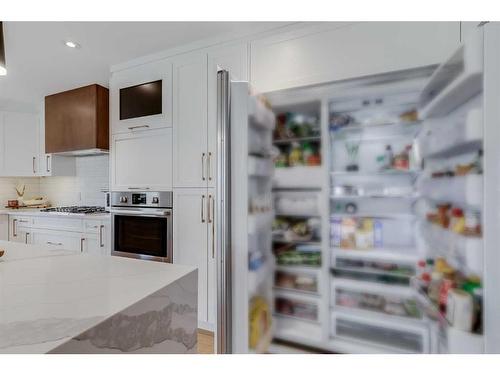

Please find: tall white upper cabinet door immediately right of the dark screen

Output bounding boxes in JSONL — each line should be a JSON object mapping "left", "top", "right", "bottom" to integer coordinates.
{"left": 173, "top": 53, "right": 208, "bottom": 187}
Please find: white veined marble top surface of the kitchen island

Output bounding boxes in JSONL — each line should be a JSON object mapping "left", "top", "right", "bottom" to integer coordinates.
{"left": 0, "top": 241, "right": 195, "bottom": 353}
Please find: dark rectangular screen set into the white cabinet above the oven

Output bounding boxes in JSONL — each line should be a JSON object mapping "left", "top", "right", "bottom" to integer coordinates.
{"left": 120, "top": 79, "right": 162, "bottom": 120}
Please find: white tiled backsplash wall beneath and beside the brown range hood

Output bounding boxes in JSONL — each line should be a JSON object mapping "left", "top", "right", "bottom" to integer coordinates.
{"left": 40, "top": 155, "right": 109, "bottom": 206}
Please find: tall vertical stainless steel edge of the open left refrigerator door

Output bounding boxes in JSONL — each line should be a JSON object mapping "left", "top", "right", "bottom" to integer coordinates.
{"left": 216, "top": 70, "right": 232, "bottom": 353}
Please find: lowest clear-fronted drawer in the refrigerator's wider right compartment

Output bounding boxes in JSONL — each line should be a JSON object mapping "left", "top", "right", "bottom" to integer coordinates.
{"left": 331, "top": 312, "right": 429, "bottom": 353}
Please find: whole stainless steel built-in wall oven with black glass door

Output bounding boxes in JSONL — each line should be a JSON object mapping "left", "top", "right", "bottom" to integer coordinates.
{"left": 111, "top": 191, "right": 173, "bottom": 263}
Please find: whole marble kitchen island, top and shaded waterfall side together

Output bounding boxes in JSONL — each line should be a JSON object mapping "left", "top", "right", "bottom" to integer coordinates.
{"left": 0, "top": 241, "right": 198, "bottom": 354}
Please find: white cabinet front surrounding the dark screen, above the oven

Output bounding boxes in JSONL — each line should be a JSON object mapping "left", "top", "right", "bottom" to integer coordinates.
{"left": 110, "top": 60, "right": 172, "bottom": 134}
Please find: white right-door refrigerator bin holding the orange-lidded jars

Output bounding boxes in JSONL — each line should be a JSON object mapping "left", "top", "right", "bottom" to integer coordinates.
{"left": 423, "top": 223, "right": 484, "bottom": 276}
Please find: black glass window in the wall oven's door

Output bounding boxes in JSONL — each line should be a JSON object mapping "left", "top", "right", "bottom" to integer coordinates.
{"left": 114, "top": 215, "right": 169, "bottom": 258}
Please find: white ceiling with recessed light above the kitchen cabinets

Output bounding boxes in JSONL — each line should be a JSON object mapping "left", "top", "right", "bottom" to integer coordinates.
{"left": 0, "top": 22, "right": 285, "bottom": 111}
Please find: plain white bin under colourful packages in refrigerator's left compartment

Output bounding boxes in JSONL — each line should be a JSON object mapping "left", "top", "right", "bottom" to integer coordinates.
{"left": 273, "top": 166, "right": 324, "bottom": 189}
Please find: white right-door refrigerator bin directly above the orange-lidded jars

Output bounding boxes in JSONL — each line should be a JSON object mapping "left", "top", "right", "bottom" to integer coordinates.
{"left": 421, "top": 174, "right": 483, "bottom": 211}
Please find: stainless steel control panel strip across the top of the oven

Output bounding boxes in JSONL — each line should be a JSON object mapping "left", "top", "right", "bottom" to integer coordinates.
{"left": 111, "top": 191, "right": 172, "bottom": 208}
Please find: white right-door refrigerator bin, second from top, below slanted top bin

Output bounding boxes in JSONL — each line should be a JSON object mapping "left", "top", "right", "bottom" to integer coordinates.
{"left": 419, "top": 108, "right": 483, "bottom": 158}
